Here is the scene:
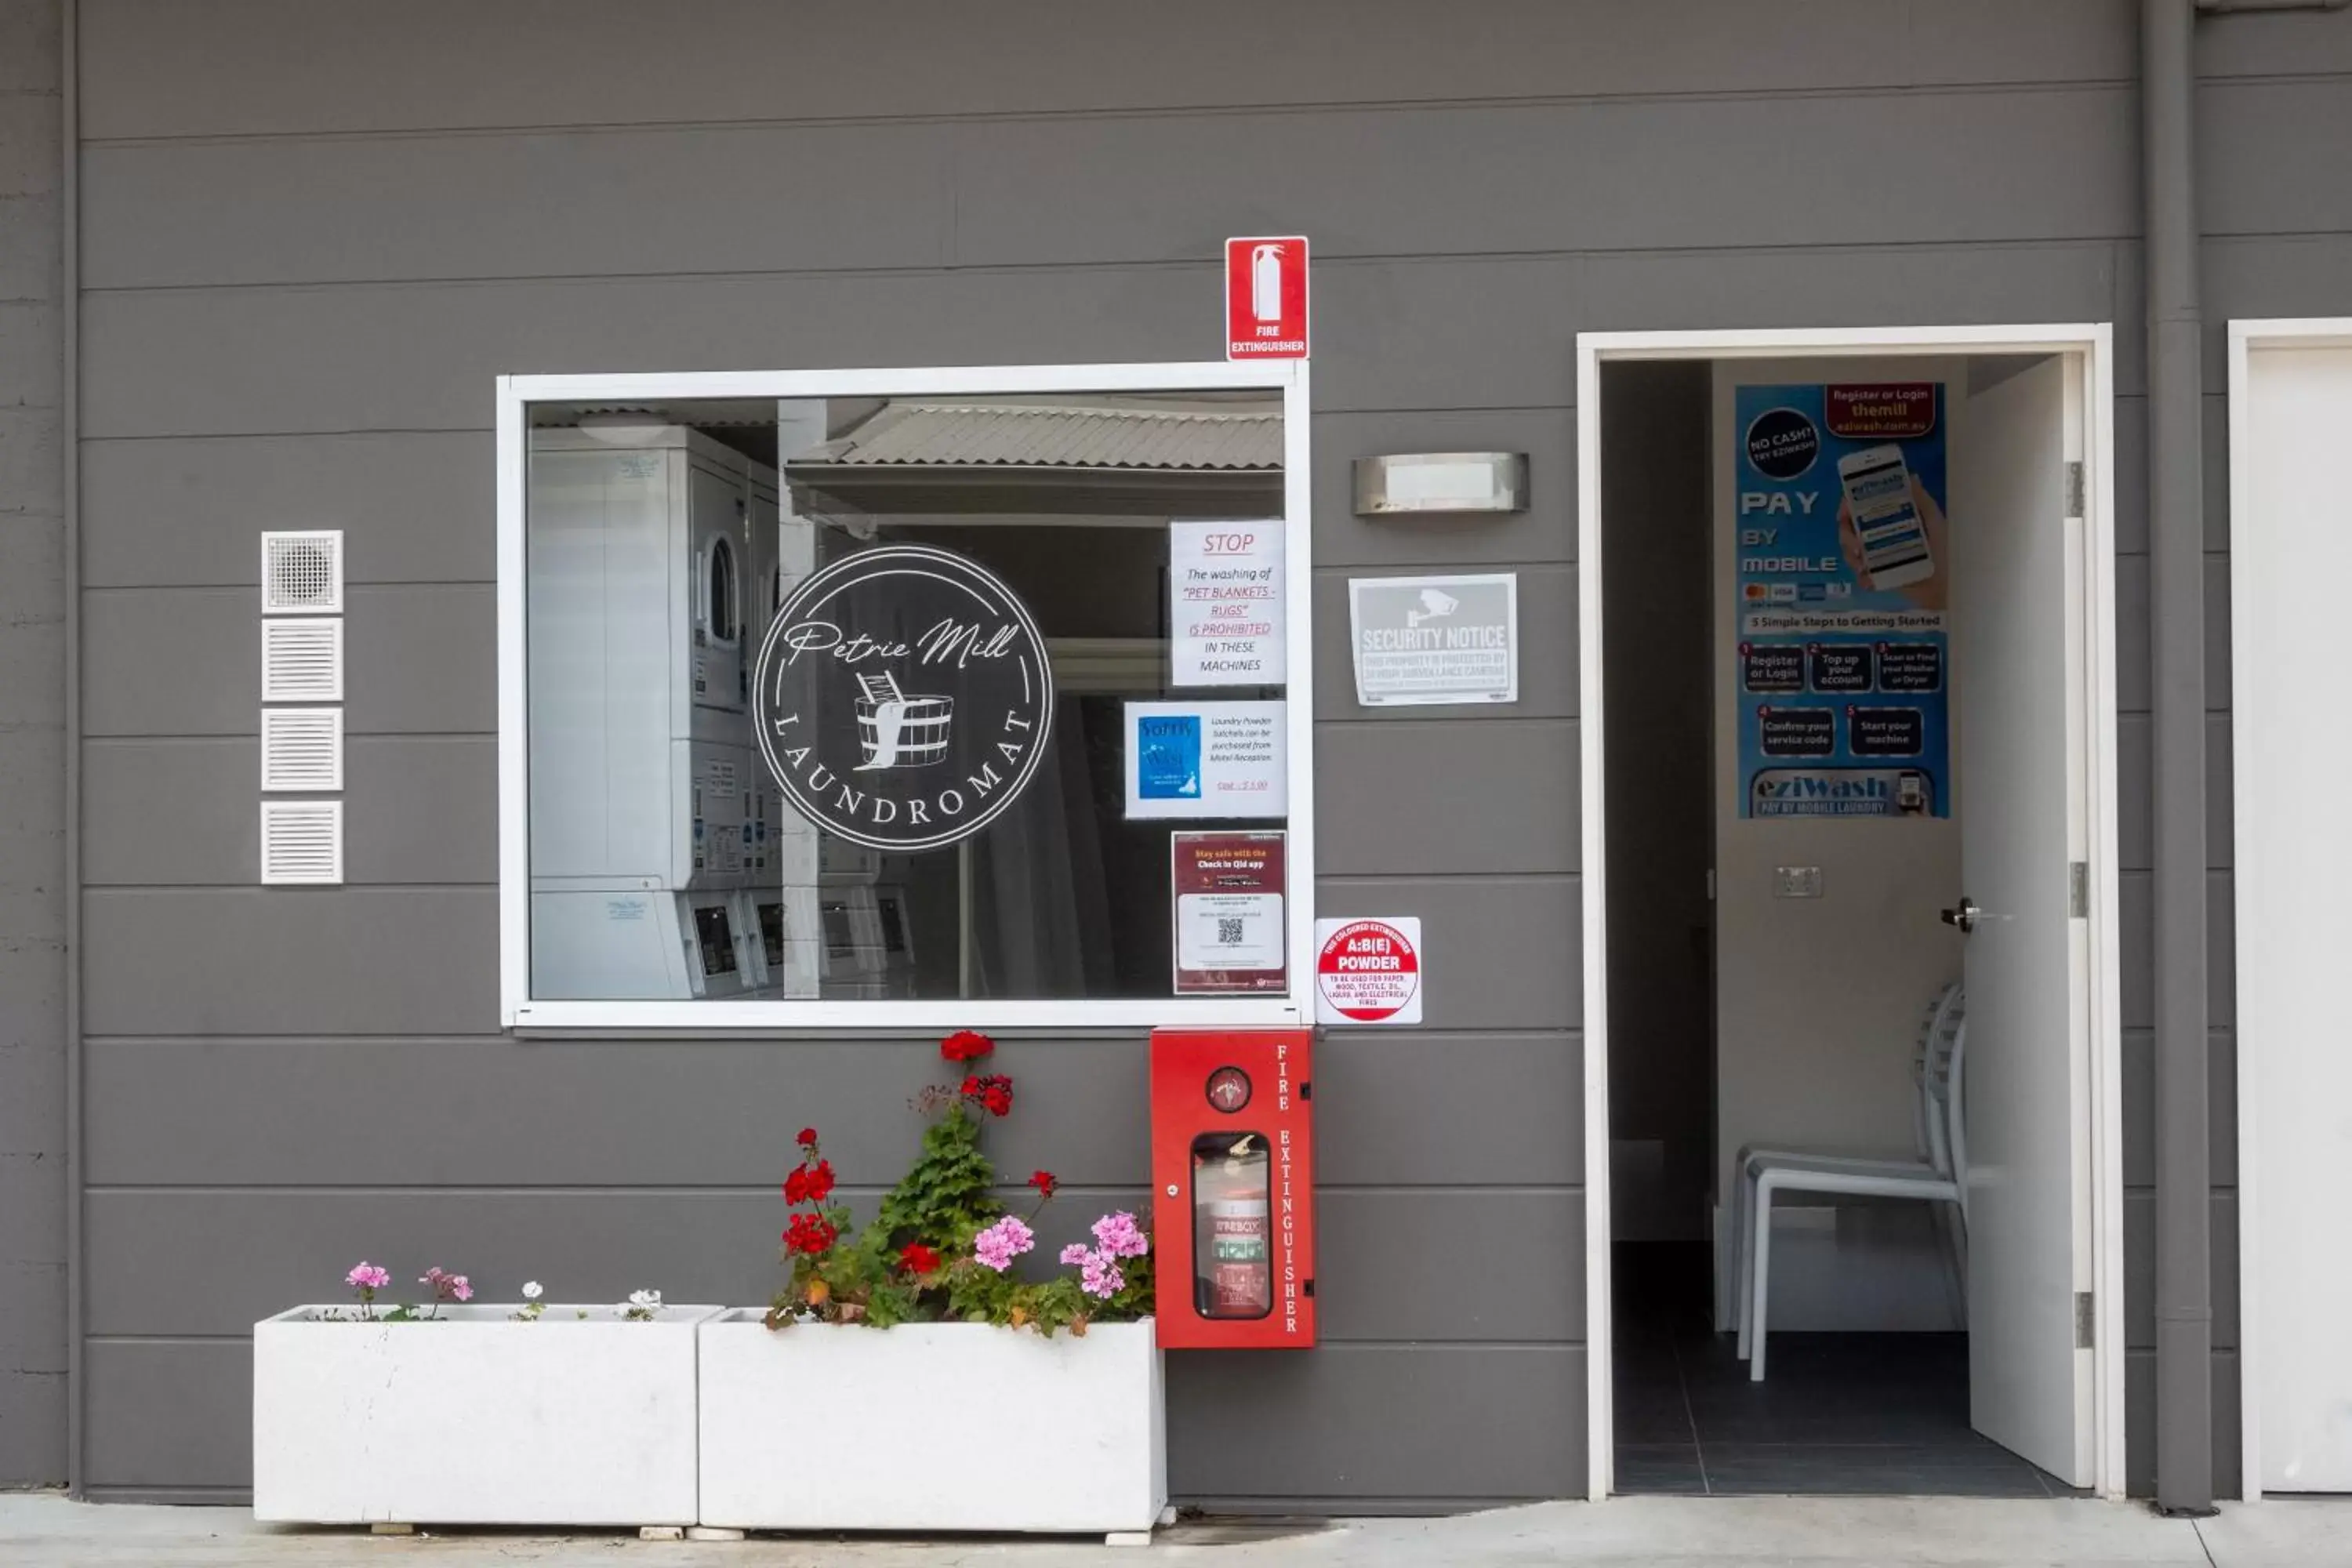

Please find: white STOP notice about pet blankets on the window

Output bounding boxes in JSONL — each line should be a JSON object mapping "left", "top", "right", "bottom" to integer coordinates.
{"left": 1169, "top": 522, "right": 1287, "bottom": 687}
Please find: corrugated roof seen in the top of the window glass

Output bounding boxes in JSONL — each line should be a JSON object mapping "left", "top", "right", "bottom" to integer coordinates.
{"left": 788, "top": 402, "right": 1282, "bottom": 475}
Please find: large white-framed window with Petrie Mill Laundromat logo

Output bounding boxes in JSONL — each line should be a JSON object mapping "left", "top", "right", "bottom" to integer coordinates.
{"left": 499, "top": 365, "right": 1312, "bottom": 1029}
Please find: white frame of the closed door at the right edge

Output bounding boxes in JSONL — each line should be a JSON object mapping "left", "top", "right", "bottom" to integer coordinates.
{"left": 2230, "top": 315, "right": 2352, "bottom": 1502}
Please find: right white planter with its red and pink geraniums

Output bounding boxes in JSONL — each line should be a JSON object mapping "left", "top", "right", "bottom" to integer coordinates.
{"left": 699, "top": 1029, "right": 1167, "bottom": 1533}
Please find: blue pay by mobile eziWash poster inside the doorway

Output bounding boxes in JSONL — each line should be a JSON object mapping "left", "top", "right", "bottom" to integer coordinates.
{"left": 1731, "top": 381, "right": 1952, "bottom": 815}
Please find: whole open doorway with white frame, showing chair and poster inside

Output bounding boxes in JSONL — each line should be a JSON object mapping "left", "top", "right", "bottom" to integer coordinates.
{"left": 1578, "top": 327, "right": 2122, "bottom": 1497}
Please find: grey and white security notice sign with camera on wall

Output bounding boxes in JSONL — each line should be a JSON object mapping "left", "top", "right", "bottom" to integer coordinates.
{"left": 1348, "top": 572, "right": 1519, "bottom": 708}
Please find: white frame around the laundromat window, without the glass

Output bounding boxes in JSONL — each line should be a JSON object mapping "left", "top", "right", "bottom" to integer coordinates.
{"left": 499, "top": 360, "right": 1315, "bottom": 1034}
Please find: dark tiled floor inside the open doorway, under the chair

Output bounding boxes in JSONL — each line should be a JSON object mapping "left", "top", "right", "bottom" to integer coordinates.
{"left": 1613, "top": 1243, "right": 2070, "bottom": 1497}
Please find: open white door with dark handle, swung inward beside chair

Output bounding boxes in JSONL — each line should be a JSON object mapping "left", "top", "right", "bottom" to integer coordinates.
{"left": 1950, "top": 358, "right": 2093, "bottom": 1486}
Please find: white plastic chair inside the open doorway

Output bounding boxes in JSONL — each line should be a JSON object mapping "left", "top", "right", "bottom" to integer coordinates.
{"left": 1733, "top": 980, "right": 1969, "bottom": 1382}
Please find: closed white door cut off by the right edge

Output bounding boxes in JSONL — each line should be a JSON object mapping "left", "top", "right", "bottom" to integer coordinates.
{"left": 2230, "top": 348, "right": 2352, "bottom": 1493}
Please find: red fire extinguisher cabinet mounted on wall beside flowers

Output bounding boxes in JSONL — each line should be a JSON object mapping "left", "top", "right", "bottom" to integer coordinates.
{"left": 1152, "top": 1029, "right": 1315, "bottom": 1349}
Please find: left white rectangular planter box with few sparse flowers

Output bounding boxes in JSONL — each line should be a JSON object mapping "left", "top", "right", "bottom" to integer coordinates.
{"left": 254, "top": 1305, "right": 720, "bottom": 1526}
